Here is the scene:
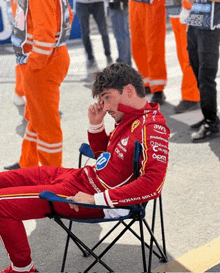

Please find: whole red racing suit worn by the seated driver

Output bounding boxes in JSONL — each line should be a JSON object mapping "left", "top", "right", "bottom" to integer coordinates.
{"left": 0, "top": 102, "right": 170, "bottom": 267}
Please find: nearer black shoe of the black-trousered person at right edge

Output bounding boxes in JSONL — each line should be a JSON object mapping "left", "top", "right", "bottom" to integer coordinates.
{"left": 191, "top": 121, "right": 220, "bottom": 142}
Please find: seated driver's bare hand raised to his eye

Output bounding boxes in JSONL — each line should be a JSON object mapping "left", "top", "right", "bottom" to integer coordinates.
{"left": 88, "top": 99, "right": 106, "bottom": 125}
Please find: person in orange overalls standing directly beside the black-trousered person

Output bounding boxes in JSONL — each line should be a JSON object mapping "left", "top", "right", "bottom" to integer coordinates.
{"left": 166, "top": 0, "right": 200, "bottom": 113}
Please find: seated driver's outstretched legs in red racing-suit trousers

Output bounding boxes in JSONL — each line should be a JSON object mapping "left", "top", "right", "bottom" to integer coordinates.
{"left": 0, "top": 166, "right": 103, "bottom": 267}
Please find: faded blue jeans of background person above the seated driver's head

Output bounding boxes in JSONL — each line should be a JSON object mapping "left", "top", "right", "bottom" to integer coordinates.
{"left": 109, "top": 7, "right": 131, "bottom": 65}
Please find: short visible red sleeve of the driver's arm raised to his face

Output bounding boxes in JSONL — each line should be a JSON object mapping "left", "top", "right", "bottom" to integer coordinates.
{"left": 88, "top": 130, "right": 109, "bottom": 158}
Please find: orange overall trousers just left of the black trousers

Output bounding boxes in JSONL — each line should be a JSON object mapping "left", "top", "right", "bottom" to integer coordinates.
{"left": 170, "top": 1, "right": 200, "bottom": 102}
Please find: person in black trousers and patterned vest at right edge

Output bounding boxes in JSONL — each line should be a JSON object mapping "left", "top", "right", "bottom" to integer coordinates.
{"left": 186, "top": 0, "right": 220, "bottom": 142}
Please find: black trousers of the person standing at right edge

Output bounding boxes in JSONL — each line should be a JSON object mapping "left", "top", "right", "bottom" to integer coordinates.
{"left": 187, "top": 26, "right": 220, "bottom": 122}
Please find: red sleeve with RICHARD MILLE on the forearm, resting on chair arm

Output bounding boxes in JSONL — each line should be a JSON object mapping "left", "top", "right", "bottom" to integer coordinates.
{"left": 103, "top": 121, "right": 170, "bottom": 207}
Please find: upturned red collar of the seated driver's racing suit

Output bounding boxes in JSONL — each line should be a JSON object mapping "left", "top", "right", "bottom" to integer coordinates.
{"left": 118, "top": 101, "right": 159, "bottom": 115}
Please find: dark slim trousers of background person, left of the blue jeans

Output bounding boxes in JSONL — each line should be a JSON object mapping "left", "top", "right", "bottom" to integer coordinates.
{"left": 76, "top": 2, "right": 111, "bottom": 60}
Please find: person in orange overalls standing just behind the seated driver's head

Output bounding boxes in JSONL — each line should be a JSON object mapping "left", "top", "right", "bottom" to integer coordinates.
{"left": 129, "top": 0, "right": 167, "bottom": 104}
